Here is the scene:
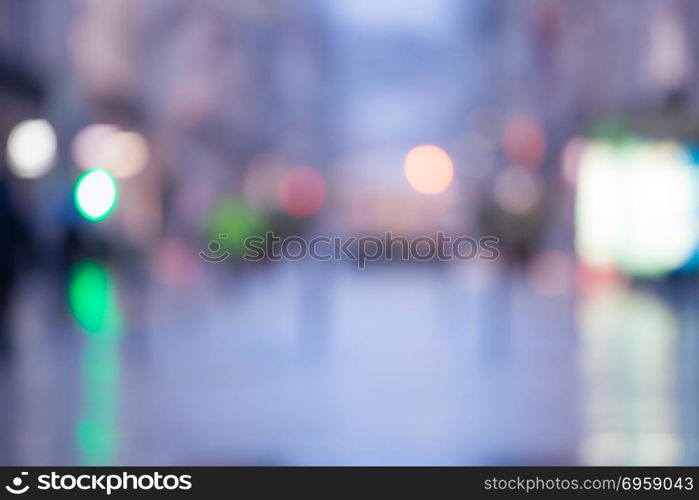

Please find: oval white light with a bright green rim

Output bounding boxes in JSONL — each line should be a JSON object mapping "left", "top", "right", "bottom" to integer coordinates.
{"left": 74, "top": 169, "right": 119, "bottom": 221}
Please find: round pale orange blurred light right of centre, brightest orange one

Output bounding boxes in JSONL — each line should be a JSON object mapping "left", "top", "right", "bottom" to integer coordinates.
{"left": 403, "top": 144, "right": 454, "bottom": 194}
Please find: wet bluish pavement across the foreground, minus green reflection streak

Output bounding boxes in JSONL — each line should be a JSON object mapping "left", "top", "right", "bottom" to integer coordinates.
{"left": 0, "top": 262, "right": 697, "bottom": 465}
